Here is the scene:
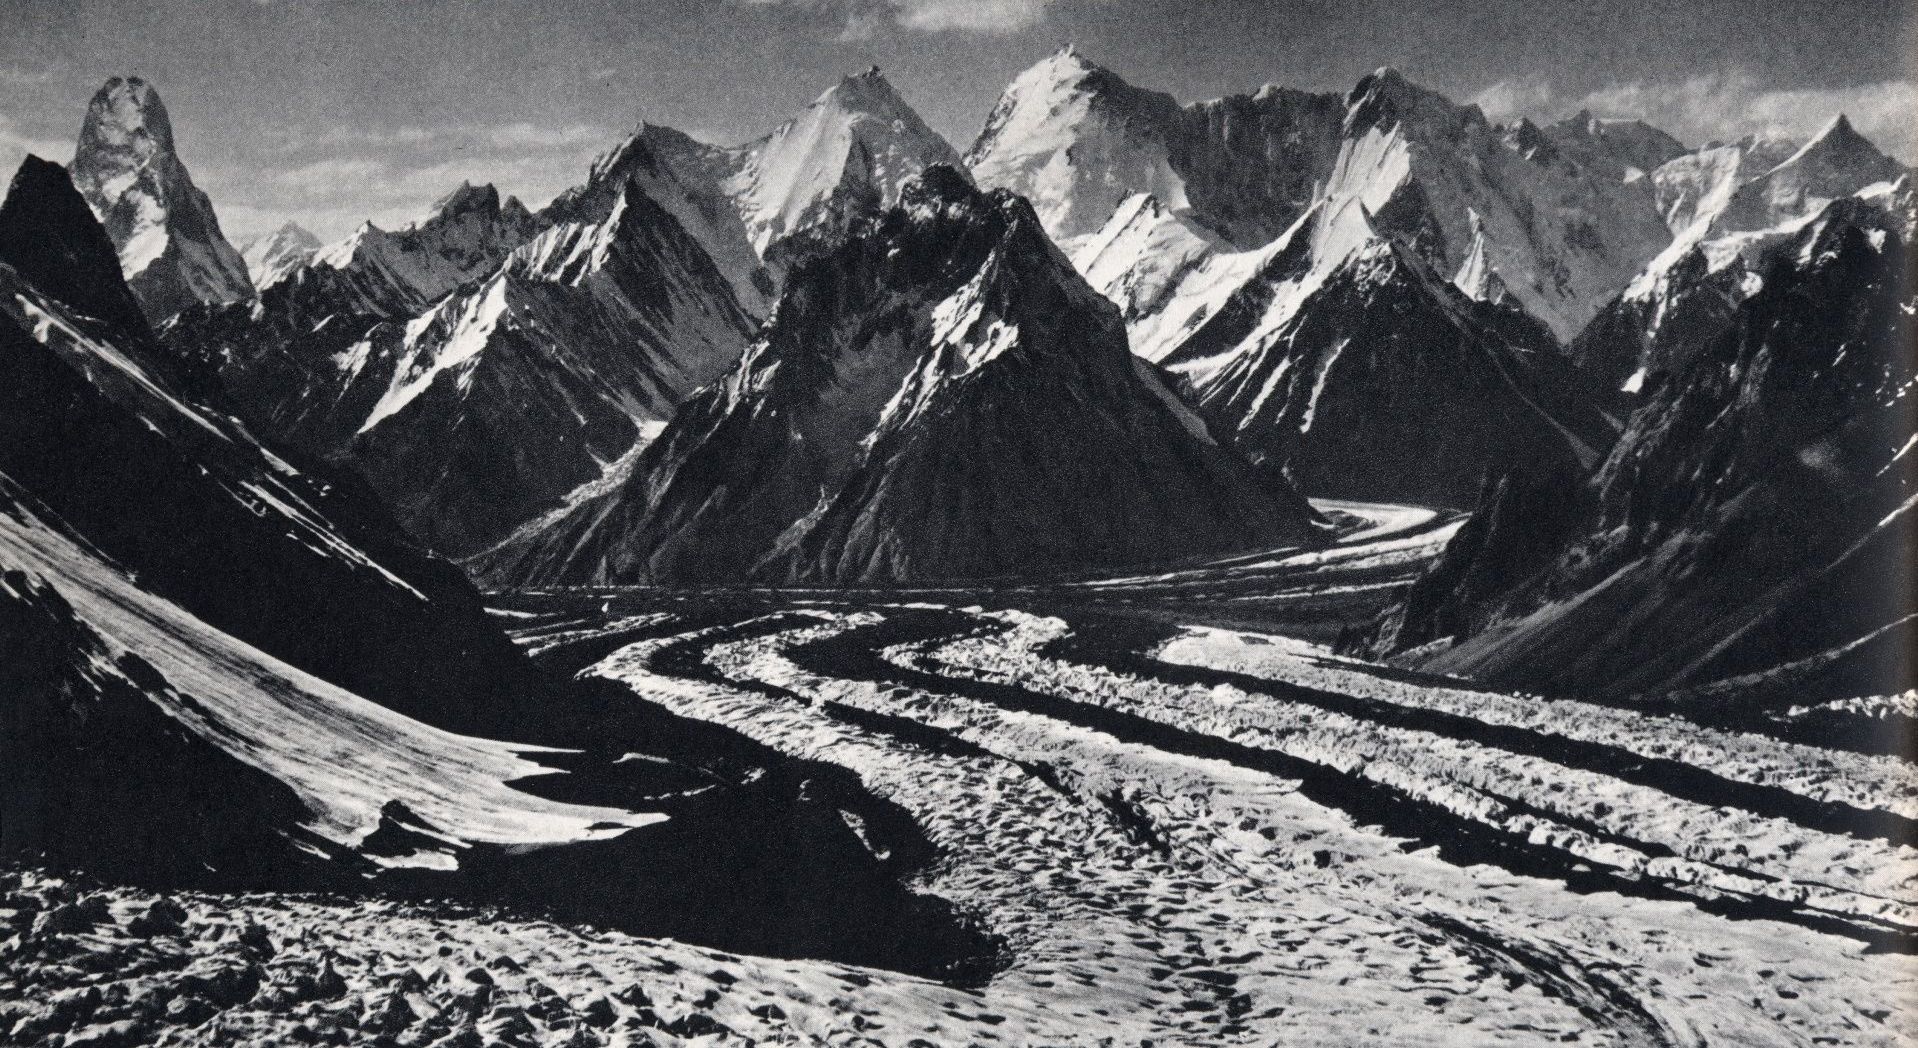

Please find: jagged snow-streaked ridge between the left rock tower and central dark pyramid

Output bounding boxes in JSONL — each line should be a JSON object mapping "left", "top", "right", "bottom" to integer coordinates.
{"left": 169, "top": 163, "right": 750, "bottom": 555}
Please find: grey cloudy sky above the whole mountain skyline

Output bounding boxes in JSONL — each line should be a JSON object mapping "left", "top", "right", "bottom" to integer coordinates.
{"left": 0, "top": 0, "right": 1918, "bottom": 240}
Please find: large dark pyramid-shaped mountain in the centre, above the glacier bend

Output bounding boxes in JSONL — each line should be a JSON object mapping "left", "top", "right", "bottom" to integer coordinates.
{"left": 481, "top": 169, "right": 1310, "bottom": 584}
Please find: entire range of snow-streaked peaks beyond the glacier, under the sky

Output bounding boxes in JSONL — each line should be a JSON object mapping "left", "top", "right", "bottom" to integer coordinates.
{"left": 14, "top": 48, "right": 1914, "bottom": 702}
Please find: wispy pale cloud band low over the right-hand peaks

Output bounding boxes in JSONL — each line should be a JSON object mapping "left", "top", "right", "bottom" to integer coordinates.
{"left": 1473, "top": 69, "right": 1918, "bottom": 163}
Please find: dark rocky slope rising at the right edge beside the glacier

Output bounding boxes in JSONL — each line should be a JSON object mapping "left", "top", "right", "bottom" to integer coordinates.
{"left": 1385, "top": 202, "right": 1918, "bottom": 695}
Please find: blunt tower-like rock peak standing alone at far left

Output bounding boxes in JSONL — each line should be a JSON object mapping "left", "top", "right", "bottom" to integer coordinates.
{"left": 71, "top": 77, "right": 253, "bottom": 321}
